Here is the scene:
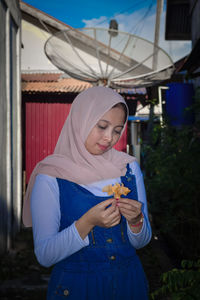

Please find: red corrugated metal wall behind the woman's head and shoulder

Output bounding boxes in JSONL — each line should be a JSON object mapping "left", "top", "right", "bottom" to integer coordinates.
{"left": 25, "top": 102, "right": 127, "bottom": 183}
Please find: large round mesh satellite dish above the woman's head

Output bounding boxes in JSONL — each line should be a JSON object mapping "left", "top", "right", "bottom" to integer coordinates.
{"left": 44, "top": 28, "right": 174, "bottom": 88}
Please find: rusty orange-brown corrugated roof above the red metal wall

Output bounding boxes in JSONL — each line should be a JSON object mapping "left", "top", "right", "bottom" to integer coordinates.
{"left": 22, "top": 73, "right": 92, "bottom": 94}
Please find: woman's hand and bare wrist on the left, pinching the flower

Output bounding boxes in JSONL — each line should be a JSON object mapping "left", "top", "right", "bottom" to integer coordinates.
{"left": 75, "top": 198, "right": 121, "bottom": 239}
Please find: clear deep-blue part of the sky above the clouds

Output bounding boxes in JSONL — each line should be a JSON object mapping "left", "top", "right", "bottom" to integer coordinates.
{"left": 24, "top": 0, "right": 152, "bottom": 28}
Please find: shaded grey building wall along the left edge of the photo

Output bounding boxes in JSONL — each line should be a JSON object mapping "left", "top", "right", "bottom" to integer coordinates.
{"left": 0, "top": 0, "right": 22, "bottom": 254}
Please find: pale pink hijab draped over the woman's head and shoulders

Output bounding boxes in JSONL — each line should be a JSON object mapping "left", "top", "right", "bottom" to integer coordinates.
{"left": 23, "top": 87, "right": 135, "bottom": 227}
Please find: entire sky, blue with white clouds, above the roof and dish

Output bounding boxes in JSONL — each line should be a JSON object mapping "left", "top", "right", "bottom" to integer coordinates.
{"left": 24, "top": 0, "right": 191, "bottom": 62}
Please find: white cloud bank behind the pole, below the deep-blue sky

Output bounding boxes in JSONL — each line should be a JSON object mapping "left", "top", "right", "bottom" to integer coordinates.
{"left": 82, "top": 5, "right": 191, "bottom": 62}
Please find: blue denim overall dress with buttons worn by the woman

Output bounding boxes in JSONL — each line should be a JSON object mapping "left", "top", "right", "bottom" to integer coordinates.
{"left": 47, "top": 166, "right": 148, "bottom": 300}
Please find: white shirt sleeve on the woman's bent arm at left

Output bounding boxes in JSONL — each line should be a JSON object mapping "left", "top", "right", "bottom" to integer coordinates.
{"left": 31, "top": 174, "right": 89, "bottom": 267}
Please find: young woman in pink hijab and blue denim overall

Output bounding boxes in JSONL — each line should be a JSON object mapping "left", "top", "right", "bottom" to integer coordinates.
{"left": 23, "top": 87, "right": 151, "bottom": 300}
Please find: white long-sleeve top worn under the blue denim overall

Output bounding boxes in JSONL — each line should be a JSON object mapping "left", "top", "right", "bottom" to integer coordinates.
{"left": 31, "top": 162, "right": 152, "bottom": 267}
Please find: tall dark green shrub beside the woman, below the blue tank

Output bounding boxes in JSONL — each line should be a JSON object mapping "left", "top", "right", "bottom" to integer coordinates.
{"left": 143, "top": 91, "right": 200, "bottom": 259}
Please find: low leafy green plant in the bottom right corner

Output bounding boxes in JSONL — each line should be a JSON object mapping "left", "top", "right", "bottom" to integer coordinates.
{"left": 150, "top": 259, "right": 200, "bottom": 300}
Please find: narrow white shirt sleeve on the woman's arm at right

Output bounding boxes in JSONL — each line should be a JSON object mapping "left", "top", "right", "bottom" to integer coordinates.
{"left": 127, "top": 161, "right": 152, "bottom": 249}
